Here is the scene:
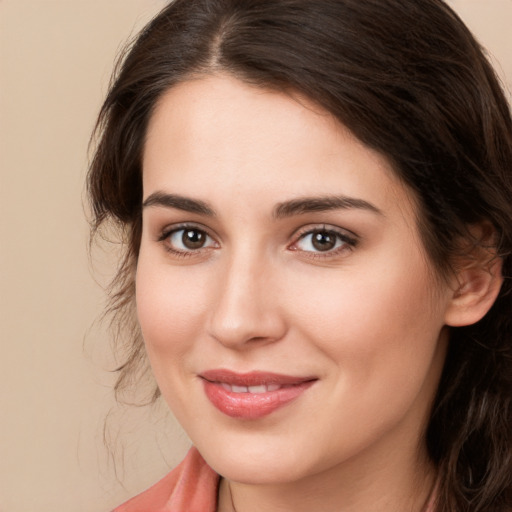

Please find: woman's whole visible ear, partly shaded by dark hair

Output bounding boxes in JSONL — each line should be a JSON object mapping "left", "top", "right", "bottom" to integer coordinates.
{"left": 445, "top": 224, "right": 503, "bottom": 327}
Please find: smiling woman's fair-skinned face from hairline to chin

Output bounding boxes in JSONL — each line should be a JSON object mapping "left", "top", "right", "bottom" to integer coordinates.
{"left": 136, "top": 75, "right": 452, "bottom": 483}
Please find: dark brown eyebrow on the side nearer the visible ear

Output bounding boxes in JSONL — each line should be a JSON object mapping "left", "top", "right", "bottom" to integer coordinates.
{"left": 273, "top": 196, "right": 384, "bottom": 219}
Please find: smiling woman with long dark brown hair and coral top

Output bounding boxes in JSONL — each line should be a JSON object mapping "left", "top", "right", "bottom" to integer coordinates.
{"left": 89, "top": 0, "right": 512, "bottom": 512}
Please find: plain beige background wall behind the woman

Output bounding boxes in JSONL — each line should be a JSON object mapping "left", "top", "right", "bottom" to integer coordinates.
{"left": 0, "top": 0, "right": 512, "bottom": 512}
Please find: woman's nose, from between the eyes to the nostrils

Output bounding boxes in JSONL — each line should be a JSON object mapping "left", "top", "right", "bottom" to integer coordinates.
{"left": 209, "top": 250, "right": 287, "bottom": 350}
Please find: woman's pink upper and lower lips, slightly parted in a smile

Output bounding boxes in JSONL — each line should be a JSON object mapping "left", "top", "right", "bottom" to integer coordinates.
{"left": 199, "top": 369, "right": 318, "bottom": 419}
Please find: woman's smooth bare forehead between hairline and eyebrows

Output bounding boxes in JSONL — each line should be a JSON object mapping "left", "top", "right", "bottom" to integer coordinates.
{"left": 143, "top": 75, "right": 418, "bottom": 220}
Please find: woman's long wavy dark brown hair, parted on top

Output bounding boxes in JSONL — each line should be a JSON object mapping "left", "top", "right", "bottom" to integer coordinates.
{"left": 88, "top": 0, "right": 512, "bottom": 512}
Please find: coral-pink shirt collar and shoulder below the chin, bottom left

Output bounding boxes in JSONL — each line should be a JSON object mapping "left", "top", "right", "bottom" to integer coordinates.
{"left": 113, "top": 447, "right": 219, "bottom": 512}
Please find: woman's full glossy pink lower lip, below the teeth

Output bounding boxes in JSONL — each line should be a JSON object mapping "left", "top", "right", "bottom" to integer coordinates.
{"left": 203, "top": 380, "right": 315, "bottom": 420}
